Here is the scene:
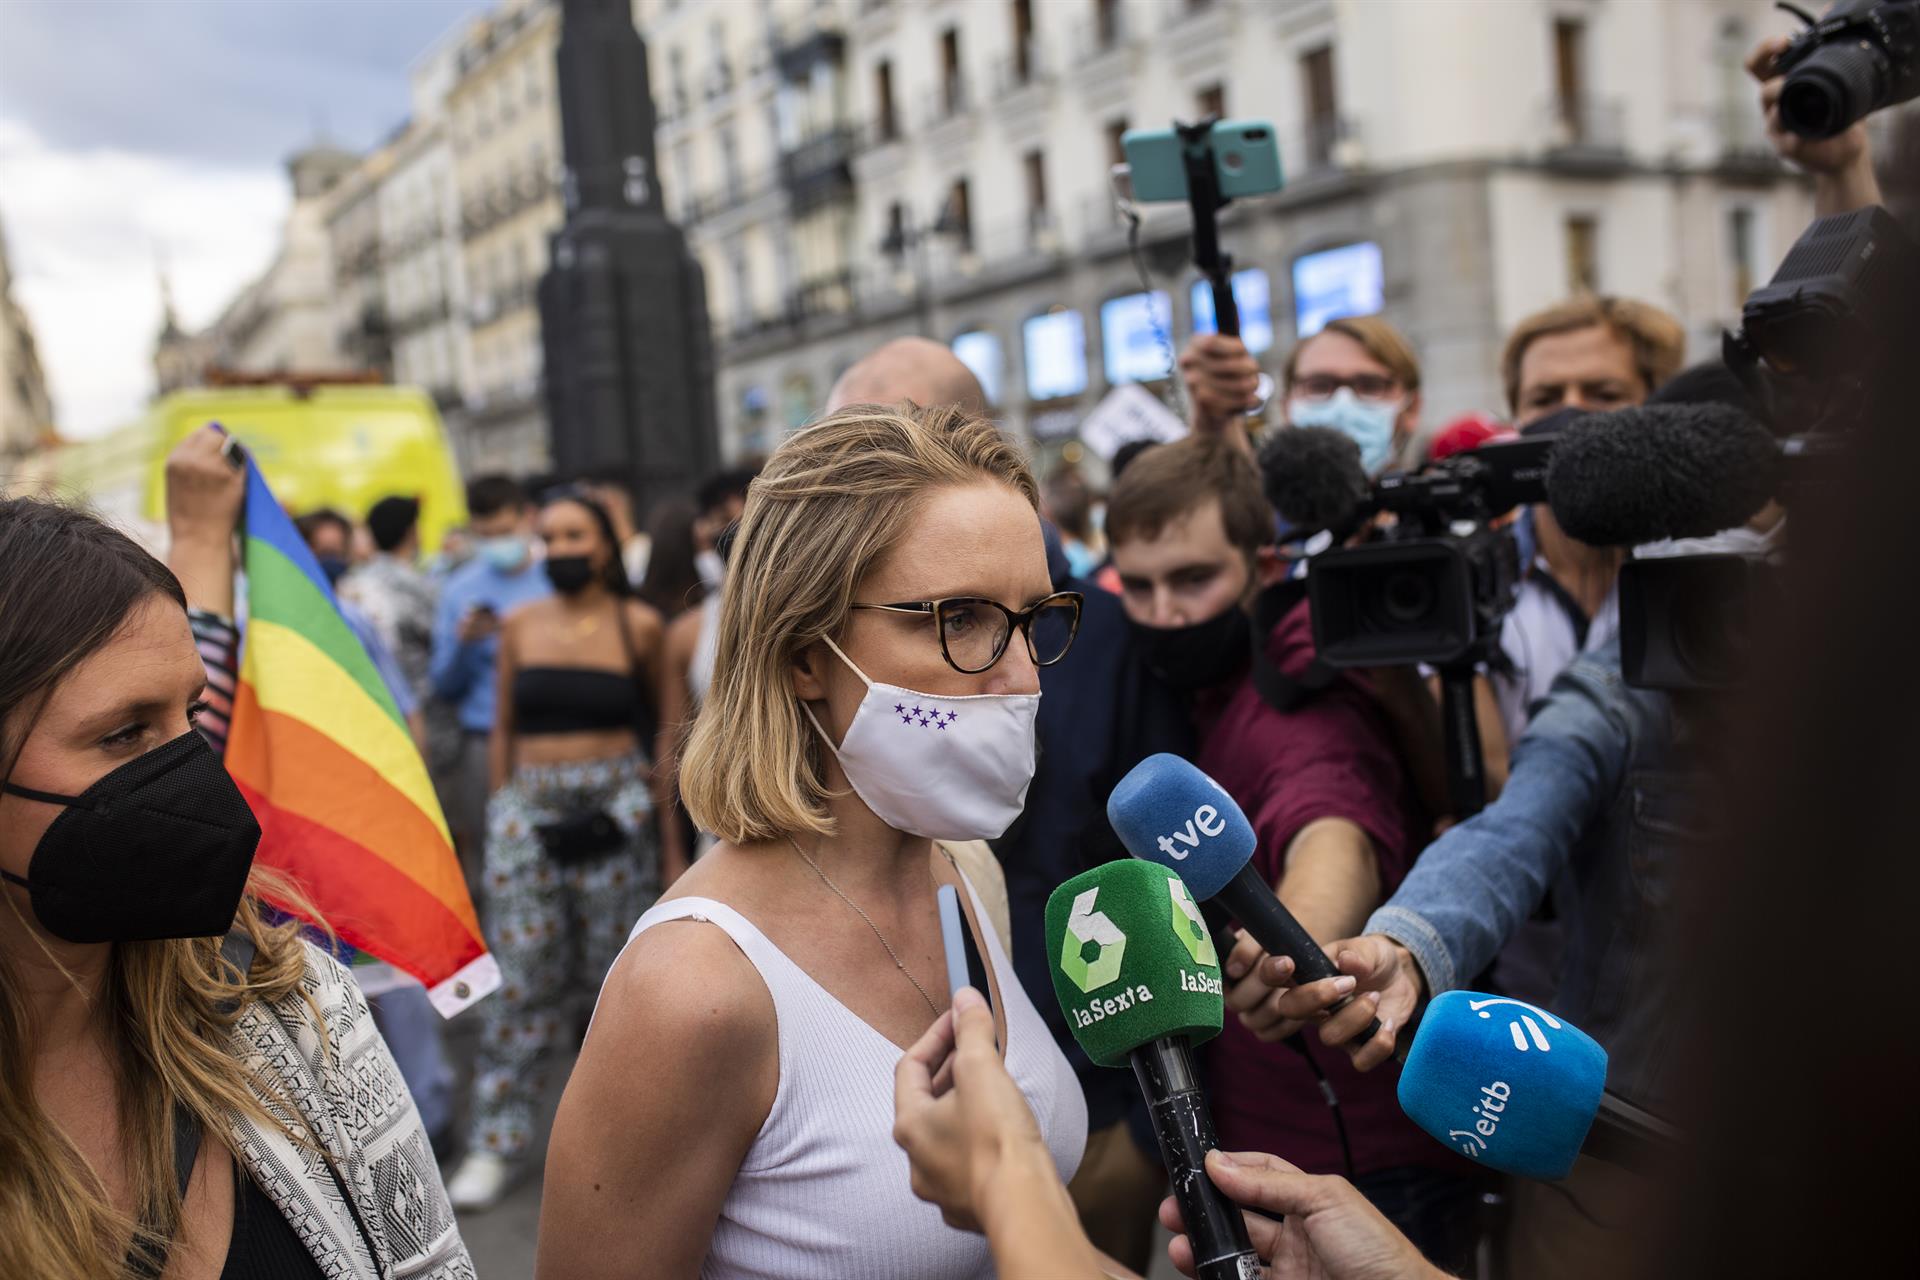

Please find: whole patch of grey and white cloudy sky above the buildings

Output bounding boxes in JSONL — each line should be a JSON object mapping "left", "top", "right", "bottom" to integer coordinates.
{"left": 0, "top": 0, "right": 488, "bottom": 438}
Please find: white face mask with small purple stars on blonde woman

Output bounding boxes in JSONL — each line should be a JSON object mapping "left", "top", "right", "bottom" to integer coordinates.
{"left": 801, "top": 639, "right": 1041, "bottom": 841}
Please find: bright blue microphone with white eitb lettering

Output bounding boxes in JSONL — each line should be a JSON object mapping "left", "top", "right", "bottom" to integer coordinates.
{"left": 1400, "top": 990, "right": 1678, "bottom": 1180}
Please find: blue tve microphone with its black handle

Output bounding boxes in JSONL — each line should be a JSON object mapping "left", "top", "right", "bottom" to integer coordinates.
{"left": 1106, "top": 752, "right": 1380, "bottom": 1044}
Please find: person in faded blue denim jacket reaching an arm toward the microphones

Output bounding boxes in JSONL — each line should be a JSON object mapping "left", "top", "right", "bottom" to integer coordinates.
{"left": 1302, "top": 639, "right": 1709, "bottom": 1109}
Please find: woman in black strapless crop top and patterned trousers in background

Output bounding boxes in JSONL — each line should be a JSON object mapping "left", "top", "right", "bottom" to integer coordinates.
{"left": 447, "top": 487, "right": 664, "bottom": 1209}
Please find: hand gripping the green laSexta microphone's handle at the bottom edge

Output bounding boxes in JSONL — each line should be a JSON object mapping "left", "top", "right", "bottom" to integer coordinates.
{"left": 1160, "top": 1151, "right": 1442, "bottom": 1280}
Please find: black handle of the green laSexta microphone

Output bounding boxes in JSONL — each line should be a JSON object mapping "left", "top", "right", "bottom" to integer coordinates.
{"left": 1131, "top": 1036, "right": 1260, "bottom": 1280}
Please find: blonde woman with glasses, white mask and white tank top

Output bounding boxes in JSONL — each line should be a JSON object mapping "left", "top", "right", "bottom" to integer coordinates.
{"left": 540, "top": 405, "right": 1087, "bottom": 1280}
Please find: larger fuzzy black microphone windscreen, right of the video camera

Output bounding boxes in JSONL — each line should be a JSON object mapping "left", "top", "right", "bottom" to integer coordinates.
{"left": 1548, "top": 405, "right": 1780, "bottom": 547}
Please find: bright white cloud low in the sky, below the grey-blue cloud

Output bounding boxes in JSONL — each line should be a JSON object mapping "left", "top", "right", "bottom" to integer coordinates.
{"left": 0, "top": 117, "right": 290, "bottom": 439}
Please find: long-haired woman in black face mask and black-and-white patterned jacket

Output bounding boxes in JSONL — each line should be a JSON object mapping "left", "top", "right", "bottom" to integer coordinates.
{"left": 0, "top": 495, "right": 474, "bottom": 1280}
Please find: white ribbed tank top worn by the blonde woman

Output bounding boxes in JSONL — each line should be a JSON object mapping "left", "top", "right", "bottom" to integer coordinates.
{"left": 628, "top": 859, "right": 1087, "bottom": 1280}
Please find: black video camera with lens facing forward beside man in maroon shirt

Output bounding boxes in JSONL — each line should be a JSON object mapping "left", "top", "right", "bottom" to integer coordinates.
{"left": 1308, "top": 436, "right": 1553, "bottom": 668}
